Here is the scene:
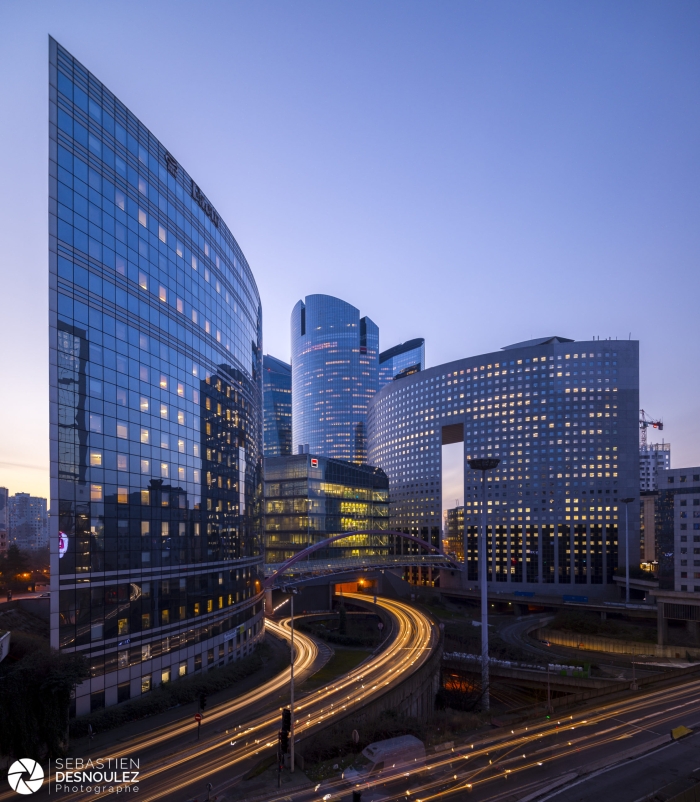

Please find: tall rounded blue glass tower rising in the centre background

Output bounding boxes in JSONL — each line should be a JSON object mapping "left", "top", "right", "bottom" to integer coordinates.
{"left": 292, "top": 295, "right": 379, "bottom": 464}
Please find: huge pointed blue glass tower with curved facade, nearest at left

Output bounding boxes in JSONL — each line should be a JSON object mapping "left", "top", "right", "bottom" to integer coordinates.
{"left": 49, "top": 39, "right": 263, "bottom": 714}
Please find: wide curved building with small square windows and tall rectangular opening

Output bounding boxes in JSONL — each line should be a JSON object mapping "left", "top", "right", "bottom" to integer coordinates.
{"left": 368, "top": 337, "right": 639, "bottom": 595}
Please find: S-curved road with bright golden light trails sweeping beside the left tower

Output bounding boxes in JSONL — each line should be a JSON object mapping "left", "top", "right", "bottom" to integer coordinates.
{"left": 19, "top": 594, "right": 439, "bottom": 802}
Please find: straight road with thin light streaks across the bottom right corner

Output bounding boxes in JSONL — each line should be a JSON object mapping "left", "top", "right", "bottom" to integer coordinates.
{"left": 282, "top": 681, "right": 700, "bottom": 802}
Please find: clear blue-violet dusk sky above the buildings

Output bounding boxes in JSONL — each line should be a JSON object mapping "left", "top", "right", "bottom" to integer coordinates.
{"left": 0, "top": 0, "right": 700, "bottom": 495}
